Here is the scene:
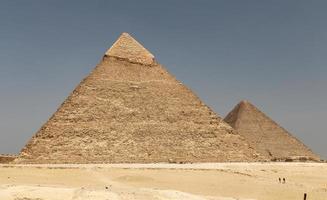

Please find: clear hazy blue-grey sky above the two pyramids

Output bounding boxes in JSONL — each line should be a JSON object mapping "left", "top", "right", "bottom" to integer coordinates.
{"left": 0, "top": 0, "right": 327, "bottom": 158}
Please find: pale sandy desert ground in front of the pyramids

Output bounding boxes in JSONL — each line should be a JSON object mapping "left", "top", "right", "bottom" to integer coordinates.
{"left": 0, "top": 163, "right": 327, "bottom": 200}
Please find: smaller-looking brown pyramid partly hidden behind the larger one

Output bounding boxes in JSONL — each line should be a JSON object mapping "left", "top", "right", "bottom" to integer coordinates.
{"left": 224, "top": 101, "right": 319, "bottom": 160}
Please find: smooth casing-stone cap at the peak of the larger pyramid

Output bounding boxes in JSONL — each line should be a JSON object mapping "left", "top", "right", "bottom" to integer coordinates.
{"left": 105, "top": 32, "right": 154, "bottom": 65}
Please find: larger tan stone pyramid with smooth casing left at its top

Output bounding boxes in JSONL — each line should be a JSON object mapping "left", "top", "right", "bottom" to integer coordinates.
{"left": 15, "top": 33, "right": 258, "bottom": 163}
